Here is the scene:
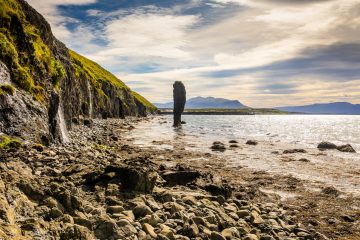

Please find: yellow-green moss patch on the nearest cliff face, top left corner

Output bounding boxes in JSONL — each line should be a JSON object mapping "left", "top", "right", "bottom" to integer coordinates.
{"left": 0, "top": 0, "right": 66, "bottom": 102}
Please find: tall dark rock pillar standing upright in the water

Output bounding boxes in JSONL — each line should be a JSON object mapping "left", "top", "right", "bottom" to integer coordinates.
{"left": 173, "top": 81, "right": 186, "bottom": 127}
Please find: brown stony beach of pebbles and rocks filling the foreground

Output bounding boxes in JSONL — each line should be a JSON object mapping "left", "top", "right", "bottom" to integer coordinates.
{"left": 0, "top": 119, "right": 359, "bottom": 240}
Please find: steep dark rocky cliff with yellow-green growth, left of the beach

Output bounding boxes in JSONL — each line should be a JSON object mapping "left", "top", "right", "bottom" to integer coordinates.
{"left": 0, "top": 0, "right": 156, "bottom": 143}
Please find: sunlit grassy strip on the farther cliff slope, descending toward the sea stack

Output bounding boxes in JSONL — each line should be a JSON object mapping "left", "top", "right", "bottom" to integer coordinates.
{"left": 70, "top": 50, "right": 156, "bottom": 111}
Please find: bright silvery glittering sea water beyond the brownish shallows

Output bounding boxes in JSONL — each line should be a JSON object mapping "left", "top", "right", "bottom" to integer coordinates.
{"left": 131, "top": 115, "right": 360, "bottom": 152}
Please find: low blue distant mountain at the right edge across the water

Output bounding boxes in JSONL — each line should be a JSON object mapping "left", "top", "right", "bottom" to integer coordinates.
{"left": 276, "top": 102, "right": 360, "bottom": 114}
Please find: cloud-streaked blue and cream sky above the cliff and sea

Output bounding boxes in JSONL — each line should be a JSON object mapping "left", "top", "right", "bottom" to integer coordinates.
{"left": 28, "top": 0, "right": 360, "bottom": 107}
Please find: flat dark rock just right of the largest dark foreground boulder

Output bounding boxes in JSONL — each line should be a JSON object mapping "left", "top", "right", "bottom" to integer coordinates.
{"left": 161, "top": 170, "right": 201, "bottom": 185}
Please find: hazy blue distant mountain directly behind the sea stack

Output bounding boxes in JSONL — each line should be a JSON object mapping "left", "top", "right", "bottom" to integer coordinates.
{"left": 154, "top": 97, "right": 246, "bottom": 109}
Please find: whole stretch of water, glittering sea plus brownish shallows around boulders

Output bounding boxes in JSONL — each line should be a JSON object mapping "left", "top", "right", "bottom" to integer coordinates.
{"left": 131, "top": 115, "right": 360, "bottom": 195}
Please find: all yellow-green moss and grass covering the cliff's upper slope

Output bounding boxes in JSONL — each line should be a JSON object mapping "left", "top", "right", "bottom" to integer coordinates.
{"left": 0, "top": 0, "right": 156, "bottom": 110}
